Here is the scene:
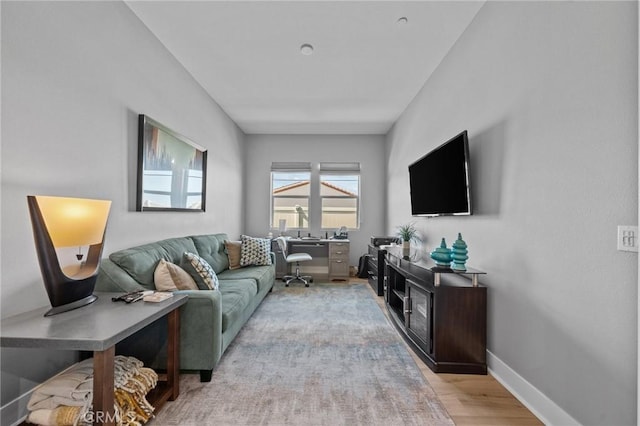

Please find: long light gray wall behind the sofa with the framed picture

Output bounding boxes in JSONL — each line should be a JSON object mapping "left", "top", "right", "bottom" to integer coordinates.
{"left": 0, "top": 2, "right": 244, "bottom": 424}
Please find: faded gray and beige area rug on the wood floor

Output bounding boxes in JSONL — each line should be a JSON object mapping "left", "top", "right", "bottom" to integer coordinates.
{"left": 151, "top": 283, "right": 453, "bottom": 426}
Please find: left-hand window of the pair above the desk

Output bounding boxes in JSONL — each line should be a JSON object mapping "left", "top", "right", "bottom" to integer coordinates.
{"left": 271, "top": 163, "right": 311, "bottom": 229}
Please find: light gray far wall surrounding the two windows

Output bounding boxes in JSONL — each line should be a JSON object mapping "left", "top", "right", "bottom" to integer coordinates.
{"left": 245, "top": 135, "right": 386, "bottom": 266}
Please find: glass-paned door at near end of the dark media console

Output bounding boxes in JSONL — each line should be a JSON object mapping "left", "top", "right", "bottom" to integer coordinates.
{"left": 406, "top": 280, "right": 433, "bottom": 355}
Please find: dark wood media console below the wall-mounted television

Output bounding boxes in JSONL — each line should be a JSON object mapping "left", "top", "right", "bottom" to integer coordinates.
{"left": 385, "top": 251, "right": 487, "bottom": 374}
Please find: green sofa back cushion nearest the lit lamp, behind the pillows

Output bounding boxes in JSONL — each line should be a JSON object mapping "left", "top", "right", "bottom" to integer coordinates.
{"left": 109, "top": 237, "right": 196, "bottom": 288}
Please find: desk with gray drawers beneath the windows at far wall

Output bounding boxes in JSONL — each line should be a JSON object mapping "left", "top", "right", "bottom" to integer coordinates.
{"left": 271, "top": 238, "right": 349, "bottom": 281}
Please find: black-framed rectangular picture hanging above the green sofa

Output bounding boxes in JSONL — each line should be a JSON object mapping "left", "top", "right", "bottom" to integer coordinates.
{"left": 136, "top": 114, "right": 207, "bottom": 212}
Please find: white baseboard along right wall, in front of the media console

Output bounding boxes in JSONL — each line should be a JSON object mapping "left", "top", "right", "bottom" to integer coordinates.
{"left": 487, "top": 351, "right": 580, "bottom": 426}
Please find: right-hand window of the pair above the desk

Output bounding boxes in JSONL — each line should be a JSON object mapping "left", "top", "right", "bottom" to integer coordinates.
{"left": 320, "top": 163, "right": 360, "bottom": 229}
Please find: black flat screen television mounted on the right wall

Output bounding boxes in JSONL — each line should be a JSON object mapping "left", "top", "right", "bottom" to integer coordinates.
{"left": 409, "top": 130, "right": 472, "bottom": 216}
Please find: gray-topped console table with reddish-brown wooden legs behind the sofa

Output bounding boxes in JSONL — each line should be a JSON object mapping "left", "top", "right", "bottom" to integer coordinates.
{"left": 0, "top": 293, "right": 188, "bottom": 425}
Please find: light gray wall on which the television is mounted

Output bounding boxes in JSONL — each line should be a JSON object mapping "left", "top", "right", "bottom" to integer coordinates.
{"left": 387, "top": 2, "right": 638, "bottom": 425}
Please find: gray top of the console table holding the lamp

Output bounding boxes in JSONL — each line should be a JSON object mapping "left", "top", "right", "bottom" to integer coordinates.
{"left": 0, "top": 293, "right": 188, "bottom": 351}
